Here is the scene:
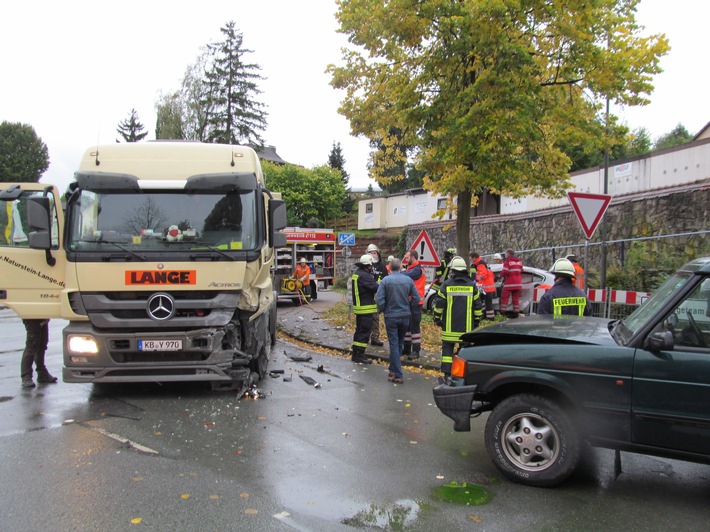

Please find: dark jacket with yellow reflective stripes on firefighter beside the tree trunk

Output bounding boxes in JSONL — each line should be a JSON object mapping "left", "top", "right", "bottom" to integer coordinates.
{"left": 434, "top": 271, "right": 483, "bottom": 342}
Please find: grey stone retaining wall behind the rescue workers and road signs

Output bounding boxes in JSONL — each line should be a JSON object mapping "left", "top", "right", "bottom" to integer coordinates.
{"left": 407, "top": 180, "right": 710, "bottom": 276}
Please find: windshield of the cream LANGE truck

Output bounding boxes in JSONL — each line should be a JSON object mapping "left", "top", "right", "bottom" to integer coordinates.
{"left": 67, "top": 190, "right": 259, "bottom": 252}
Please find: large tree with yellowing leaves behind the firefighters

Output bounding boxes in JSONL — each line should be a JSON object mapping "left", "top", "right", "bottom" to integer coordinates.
{"left": 329, "top": 0, "right": 668, "bottom": 256}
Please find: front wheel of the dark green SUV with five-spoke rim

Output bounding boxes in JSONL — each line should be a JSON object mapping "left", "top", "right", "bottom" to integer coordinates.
{"left": 485, "top": 394, "right": 581, "bottom": 487}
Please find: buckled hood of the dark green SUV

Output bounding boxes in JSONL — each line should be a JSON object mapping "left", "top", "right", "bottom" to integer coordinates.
{"left": 462, "top": 315, "right": 617, "bottom": 346}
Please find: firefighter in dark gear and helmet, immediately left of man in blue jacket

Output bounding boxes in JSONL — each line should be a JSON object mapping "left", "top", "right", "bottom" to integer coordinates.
{"left": 351, "top": 253, "right": 377, "bottom": 364}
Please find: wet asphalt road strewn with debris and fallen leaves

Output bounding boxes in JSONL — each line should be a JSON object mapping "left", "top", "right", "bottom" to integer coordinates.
{"left": 0, "top": 310, "right": 710, "bottom": 531}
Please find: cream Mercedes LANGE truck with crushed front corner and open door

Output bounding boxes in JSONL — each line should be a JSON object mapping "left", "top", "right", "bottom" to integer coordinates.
{"left": 0, "top": 141, "right": 286, "bottom": 390}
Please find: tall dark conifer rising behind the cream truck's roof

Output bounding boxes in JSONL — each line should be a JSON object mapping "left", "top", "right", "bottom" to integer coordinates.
{"left": 200, "top": 21, "right": 266, "bottom": 147}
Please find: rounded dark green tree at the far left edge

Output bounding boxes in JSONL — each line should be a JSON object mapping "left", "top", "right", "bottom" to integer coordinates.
{"left": 0, "top": 121, "right": 49, "bottom": 183}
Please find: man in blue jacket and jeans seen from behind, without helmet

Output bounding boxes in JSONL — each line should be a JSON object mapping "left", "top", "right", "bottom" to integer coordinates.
{"left": 375, "top": 259, "right": 420, "bottom": 384}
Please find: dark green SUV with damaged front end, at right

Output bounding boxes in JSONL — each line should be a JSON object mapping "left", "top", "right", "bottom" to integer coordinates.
{"left": 434, "top": 257, "right": 710, "bottom": 486}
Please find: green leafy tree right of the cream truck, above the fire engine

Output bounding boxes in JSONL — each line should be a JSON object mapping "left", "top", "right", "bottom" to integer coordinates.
{"left": 262, "top": 161, "right": 346, "bottom": 226}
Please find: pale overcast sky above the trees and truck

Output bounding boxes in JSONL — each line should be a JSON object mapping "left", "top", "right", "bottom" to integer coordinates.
{"left": 0, "top": 0, "right": 710, "bottom": 189}
